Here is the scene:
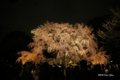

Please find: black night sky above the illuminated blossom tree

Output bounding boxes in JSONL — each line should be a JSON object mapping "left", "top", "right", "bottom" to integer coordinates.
{"left": 0, "top": 0, "right": 120, "bottom": 40}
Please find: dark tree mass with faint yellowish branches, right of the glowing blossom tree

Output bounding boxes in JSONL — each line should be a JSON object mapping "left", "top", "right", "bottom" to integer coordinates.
{"left": 88, "top": 7, "right": 120, "bottom": 61}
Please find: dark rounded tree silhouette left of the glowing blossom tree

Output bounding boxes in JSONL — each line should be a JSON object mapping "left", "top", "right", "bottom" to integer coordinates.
{"left": 0, "top": 31, "right": 32, "bottom": 64}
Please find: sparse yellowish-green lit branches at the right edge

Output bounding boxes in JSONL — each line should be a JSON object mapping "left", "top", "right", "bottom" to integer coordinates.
{"left": 97, "top": 9, "right": 120, "bottom": 44}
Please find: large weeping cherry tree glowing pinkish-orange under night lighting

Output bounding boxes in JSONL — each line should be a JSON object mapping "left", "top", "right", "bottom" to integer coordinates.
{"left": 17, "top": 22, "right": 109, "bottom": 64}
